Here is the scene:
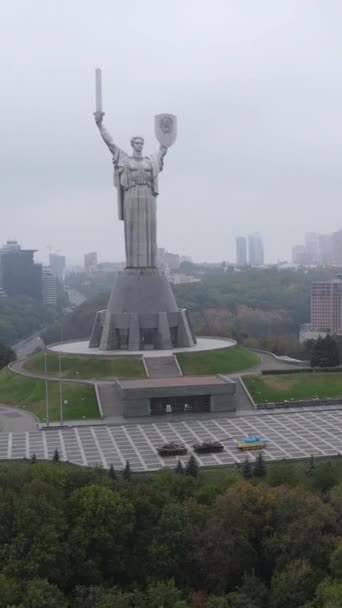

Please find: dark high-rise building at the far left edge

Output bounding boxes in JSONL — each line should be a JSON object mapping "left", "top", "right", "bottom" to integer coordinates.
{"left": 0, "top": 241, "right": 42, "bottom": 300}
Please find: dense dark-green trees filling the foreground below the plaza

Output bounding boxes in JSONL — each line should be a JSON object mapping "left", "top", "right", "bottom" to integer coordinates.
{"left": 0, "top": 458, "right": 342, "bottom": 608}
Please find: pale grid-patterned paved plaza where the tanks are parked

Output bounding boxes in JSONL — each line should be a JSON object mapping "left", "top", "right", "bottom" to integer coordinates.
{"left": 0, "top": 409, "right": 342, "bottom": 472}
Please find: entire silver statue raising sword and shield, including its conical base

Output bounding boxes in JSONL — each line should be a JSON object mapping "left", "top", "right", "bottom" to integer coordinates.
{"left": 89, "top": 68, "right": 196, "bottom": 351}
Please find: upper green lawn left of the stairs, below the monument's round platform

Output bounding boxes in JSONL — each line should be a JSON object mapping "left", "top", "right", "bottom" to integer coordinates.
{"left": 24, "top": 352, "right": 146, "bottom": 380}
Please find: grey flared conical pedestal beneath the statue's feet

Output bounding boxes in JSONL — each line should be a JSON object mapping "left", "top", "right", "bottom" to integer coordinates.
{"left": 89, "top": 268, "right": 196, "bottom": 351}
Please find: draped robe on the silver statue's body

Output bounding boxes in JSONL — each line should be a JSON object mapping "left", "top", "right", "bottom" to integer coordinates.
{"left": 113, "top": 148, "right": 163, "bottom": 268}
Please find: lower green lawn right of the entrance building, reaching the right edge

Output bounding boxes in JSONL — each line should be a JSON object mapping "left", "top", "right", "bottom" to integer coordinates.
{"left": 243, "top": 372, "right": 342, "bottom": 403}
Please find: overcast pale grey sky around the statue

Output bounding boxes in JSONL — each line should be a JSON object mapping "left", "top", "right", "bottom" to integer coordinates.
{"left": 0, "top": 0, "right": 342, "bottom": 263}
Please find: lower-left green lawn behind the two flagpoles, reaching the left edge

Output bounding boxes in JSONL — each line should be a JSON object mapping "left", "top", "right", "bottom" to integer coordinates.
{"left": 0, "top": 368, "right": 99, "bottom": 421}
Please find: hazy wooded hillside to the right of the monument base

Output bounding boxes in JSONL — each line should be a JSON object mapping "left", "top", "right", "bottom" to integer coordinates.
{"left": 176, "top": 265, "right": 329, "bottom": 340}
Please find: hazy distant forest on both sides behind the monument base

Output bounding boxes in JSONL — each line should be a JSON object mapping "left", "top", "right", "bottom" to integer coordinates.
{"left": 57, "top": 262, "right": 331, "bottom": 357}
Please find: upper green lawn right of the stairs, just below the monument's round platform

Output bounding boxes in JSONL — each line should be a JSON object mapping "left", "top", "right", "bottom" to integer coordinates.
{"left": 177, "top": 346, "right": 260, "bottom": 376}
